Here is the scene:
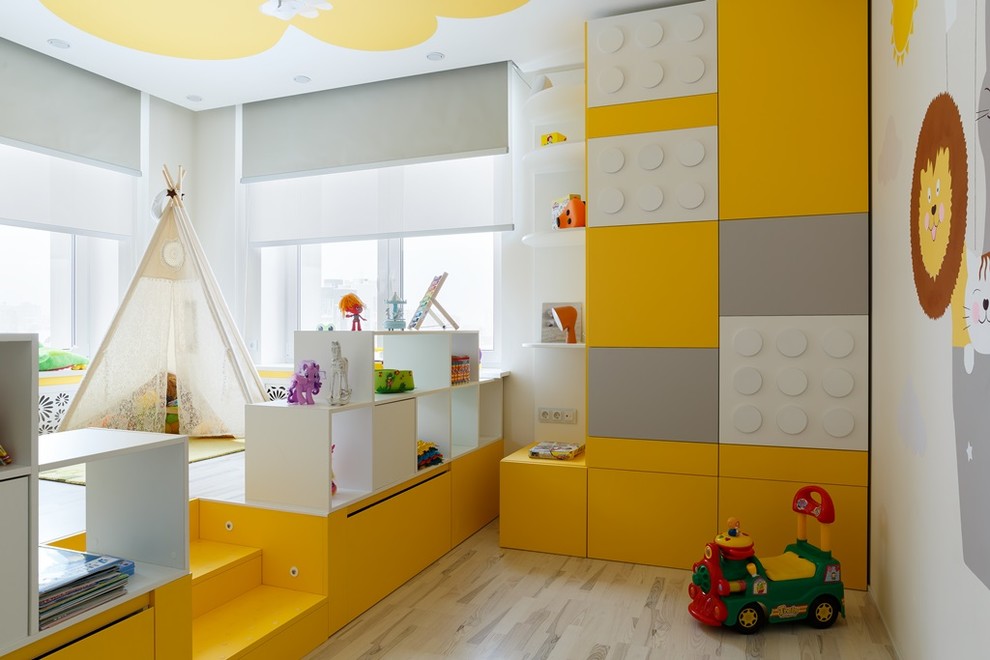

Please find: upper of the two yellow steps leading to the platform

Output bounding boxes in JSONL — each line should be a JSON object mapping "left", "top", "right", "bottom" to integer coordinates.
{"left": 189, "top": 539, "right": 261, "bottom": 618}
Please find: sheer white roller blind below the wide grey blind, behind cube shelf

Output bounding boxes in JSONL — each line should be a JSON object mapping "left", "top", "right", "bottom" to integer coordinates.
{"left": 245, "top": 155, "right": 511, "bottom": 245}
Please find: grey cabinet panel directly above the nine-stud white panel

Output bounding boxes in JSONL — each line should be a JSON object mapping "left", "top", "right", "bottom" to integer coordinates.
{"left": 718, "top": 213, "right": 870, "bottom": 316}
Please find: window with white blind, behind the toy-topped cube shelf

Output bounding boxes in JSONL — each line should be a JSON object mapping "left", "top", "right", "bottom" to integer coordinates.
{"left": 245, "top": 156, "right": 511, "bottom": 364}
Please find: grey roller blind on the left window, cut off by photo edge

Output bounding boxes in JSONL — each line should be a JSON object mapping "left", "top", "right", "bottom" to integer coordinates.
{"left": 0, "top": 39, "right": 141, "bottom": 173}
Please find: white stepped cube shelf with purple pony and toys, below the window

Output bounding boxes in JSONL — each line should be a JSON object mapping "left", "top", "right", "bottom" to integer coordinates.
{"left": 244, "top": 331, "right": 502, "bottom": 513}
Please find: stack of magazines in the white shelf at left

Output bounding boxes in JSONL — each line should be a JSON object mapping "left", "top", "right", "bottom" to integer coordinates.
{"left": 38, "top": 545, "right": 134, "bottom": 630}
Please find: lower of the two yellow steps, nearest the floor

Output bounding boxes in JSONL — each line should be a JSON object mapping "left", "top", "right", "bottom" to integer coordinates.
{"left": 193, "top": 585, "right": 329, "bottom": 660}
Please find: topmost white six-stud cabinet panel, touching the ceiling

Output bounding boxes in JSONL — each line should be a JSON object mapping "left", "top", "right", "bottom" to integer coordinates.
{"left": 588, "top": 0, "right": 718, "bottom": 107}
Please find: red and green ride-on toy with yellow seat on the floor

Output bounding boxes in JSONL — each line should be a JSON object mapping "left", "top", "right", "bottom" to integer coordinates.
{"left": 688, "top": 486, "right": 846, "bottom": 634}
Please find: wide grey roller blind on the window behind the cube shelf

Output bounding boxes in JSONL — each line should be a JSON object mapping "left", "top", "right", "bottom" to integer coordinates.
{"left": 243, "top": 62, "right": 509, "bottom": 182}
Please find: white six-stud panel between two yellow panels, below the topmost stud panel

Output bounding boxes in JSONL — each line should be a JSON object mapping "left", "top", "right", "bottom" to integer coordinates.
{"left": 588, "top": 126, "right": 718, "bottom": 227}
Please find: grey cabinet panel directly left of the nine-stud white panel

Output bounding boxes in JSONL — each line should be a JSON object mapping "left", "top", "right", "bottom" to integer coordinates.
{"left": 588, "top": 348, "right": 718, "bottom": 442}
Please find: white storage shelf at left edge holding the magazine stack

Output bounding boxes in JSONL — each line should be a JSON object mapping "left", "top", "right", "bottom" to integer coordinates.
{"left": 0, "top": 334, "right": 189, "bottom": 656}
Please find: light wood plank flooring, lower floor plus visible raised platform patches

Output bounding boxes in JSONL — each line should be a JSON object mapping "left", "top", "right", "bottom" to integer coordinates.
{"left": 39, "top": 454, "right": 896, "bottom": 660}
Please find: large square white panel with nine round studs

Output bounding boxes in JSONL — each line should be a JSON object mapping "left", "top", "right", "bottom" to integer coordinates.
{"left": 719, "top": 316, "right": 869, "bottom": 451}
